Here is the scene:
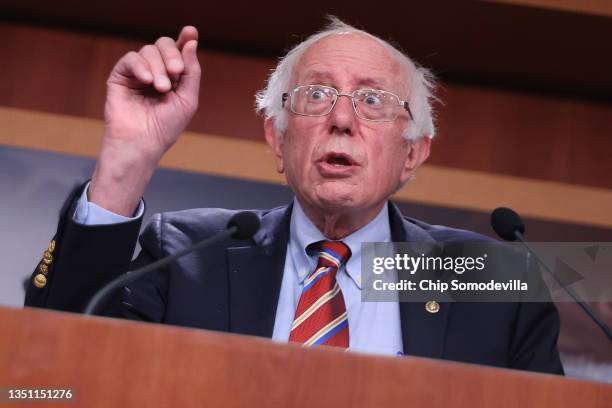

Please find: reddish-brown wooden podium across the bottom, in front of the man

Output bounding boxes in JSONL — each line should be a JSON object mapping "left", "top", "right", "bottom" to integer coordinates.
{"left": 0, "top": 307, "right": 612, "bottom": 408}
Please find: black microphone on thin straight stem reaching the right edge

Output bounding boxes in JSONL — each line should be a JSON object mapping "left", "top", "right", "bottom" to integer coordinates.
{"left": 491, "top": 207, "right": 612, "bottom": 341}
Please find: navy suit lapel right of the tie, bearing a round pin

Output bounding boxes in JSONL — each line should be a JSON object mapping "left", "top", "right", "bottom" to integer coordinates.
{"left": 389, "top": 203, "right": 451, "bottom": 358}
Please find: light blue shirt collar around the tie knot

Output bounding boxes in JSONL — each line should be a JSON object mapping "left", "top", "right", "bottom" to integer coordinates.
{"left": 289, "top": 199, "right": 391, "bottom": 289}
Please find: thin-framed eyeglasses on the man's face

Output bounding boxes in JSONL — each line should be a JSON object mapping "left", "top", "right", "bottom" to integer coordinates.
{"left": 283, "top": 85, "right": 414, "bottom": 122}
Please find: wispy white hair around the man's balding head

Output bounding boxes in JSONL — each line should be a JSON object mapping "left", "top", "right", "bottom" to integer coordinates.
{"left": 255, "top": 16, "right": 436, "bottom": 140}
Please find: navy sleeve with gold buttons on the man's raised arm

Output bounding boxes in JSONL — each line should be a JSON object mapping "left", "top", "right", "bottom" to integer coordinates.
{"left": 25, "top": 183, "right": 145, "bottom": 314}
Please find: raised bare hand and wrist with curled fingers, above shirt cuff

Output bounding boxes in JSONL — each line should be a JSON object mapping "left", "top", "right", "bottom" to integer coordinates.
{"left": 89, "top": 26, "right": 200, "bottom": 216}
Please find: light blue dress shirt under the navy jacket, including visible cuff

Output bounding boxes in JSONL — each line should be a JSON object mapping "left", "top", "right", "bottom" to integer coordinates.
{"left": 74, "top": 185, "right": 403, "bottom": 356}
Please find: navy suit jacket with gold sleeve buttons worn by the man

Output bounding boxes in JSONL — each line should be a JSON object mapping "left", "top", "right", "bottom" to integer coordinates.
{"left": 25, "top": 186, "right": 563, "bottom": 374}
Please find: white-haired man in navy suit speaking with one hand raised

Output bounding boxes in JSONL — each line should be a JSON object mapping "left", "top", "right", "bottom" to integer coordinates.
{"left": 26, "top": 20, "right": 563, "bottom": 373}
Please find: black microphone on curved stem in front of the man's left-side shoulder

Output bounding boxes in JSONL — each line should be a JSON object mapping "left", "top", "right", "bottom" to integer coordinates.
{"left": 83, "top": 211, "right": 259, "bottom": 315}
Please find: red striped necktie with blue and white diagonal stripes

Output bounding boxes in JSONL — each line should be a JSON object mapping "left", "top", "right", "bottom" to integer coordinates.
{"left": 289, "top": 241, "right": 351, "bottom": 348}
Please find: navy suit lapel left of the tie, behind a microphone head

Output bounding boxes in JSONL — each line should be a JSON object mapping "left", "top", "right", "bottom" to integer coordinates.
{"left": 227, "top": 205, "right": 292, "bottom": 337}
